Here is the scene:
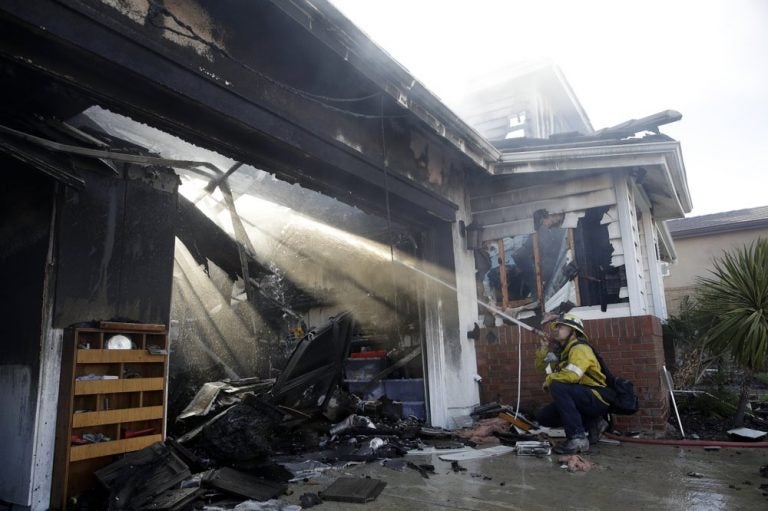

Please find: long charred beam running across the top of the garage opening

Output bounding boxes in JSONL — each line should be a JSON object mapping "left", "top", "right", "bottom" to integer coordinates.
{"left": 0, "top": 1, "right": 457, "bottom": 225}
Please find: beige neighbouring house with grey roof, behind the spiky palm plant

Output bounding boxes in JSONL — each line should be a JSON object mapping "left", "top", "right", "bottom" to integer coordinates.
{"left": 664, "top": 206, "right": 768, "bottom": 314}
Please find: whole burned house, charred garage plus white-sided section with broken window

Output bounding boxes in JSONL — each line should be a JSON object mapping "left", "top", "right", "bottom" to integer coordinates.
{"left": 0, "top": 0, "right": 690, "bottom": 509}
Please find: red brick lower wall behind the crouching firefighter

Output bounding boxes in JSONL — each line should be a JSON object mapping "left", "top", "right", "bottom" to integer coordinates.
{"left": 475, "top": 316, "right": 669, "bottom": 434}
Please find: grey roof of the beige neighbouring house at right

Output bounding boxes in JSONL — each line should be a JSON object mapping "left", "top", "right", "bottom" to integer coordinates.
{"left": 667, "top": 206, "right": 768, "bottom": 238}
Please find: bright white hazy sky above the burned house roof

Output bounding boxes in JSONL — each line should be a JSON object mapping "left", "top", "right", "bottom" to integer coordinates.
{"left": 331, "top": 0, "right": 768, "bottom": 216}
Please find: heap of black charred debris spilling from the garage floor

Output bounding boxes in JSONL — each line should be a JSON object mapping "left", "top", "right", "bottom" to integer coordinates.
{"left": 82, "top": 312, "right": 549, "bottom": 511}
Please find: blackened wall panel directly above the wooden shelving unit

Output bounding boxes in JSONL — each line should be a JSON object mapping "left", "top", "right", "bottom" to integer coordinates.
{"left": 54, "top": 166, "right": 178, "bottom": 328}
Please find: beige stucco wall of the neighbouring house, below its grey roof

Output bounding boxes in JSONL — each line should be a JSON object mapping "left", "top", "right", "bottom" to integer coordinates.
{"left": 664, "top": 229, "right": 768, "bottom": 314}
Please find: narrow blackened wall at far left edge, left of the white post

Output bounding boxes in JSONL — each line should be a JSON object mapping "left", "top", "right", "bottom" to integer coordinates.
{"left": 0, "top": 159, "right": 53, "bottom": 505}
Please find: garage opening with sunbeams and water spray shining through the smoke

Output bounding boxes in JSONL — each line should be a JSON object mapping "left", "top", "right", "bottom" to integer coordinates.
{"left": 82, "top": 107, "right": 438, "bottom": 434}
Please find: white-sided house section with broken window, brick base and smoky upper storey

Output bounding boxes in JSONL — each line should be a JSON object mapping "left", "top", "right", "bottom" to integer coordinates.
{"left": 464, "top": 63, "right": 692, "bottom": 432}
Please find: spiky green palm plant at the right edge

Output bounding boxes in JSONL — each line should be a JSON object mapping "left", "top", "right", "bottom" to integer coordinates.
{"left": 697, "top": 238, "right": 768, "bottom": 426}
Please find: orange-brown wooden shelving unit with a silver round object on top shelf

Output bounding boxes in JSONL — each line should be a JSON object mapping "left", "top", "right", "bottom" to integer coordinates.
{"left": 51, "top": 322, "right": 168, "bottom": 509}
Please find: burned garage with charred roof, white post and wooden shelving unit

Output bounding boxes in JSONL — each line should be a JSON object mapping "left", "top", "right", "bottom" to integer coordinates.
{"left": 2, "top": 1, "right": 497, "bottom": 508}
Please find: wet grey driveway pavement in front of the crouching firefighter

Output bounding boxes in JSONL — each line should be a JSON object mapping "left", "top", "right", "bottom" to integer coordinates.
{"left": 283, "top": 444, "right": 768, "bottom": 511}
